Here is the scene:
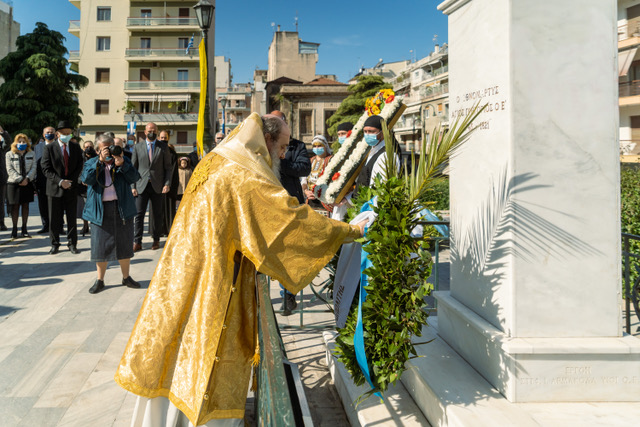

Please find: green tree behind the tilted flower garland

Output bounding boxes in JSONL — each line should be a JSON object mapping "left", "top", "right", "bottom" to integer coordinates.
{"left": 326, "top": 76, "right": 391, "bottom": 143}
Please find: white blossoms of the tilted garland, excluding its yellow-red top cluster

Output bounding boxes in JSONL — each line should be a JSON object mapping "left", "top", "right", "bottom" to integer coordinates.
{"left": 313, "top": 96, "right": 403, "bottom": 203}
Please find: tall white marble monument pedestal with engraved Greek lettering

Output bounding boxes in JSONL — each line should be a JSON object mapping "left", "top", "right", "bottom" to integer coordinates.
{"left": 436, "top": 0, "right": 640, "bottom": 408}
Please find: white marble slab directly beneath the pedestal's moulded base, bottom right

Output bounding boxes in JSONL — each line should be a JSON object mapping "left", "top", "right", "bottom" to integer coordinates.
{"left": 401, "top": 317, "right": 640, "bottom": 427}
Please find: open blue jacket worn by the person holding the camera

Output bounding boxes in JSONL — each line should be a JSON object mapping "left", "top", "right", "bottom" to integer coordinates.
{"left": 80, "top": 157, "right": 140, "bottom": 225}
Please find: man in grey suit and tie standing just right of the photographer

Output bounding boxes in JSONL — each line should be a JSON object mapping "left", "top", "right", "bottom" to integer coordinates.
{"left": 131, "top": 123, "right": 172, "bottom": 252}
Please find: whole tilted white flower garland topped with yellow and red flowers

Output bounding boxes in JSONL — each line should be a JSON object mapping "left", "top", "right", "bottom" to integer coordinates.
{"left": 313, "top": 89, "right": 402, "bottom": 203}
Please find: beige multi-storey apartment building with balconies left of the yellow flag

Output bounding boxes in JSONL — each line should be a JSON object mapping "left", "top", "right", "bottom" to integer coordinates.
{"left": 69, "top": 0, "right": 215, "bottom": 152}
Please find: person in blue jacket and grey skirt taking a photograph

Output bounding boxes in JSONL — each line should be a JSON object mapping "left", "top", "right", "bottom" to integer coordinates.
{"left": 81, "top": 134, "right": 140, "bottom": 294}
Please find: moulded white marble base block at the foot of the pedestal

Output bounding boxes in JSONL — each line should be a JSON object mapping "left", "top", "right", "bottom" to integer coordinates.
{"left": 435, "top": 291, "right": 640, "bottom": 403}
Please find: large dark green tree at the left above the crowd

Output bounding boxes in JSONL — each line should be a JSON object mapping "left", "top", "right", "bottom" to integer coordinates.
{"left": 0, "top": 22, "right": 89, "bottom": 141}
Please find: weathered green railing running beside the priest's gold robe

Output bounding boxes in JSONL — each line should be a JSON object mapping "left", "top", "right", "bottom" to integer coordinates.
{"left": 255, "top": 274, "right": 313, "bottom": 426}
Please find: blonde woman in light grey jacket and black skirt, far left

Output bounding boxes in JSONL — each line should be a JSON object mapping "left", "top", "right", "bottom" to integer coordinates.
{"left": 5, "top": 133, "right": 36, "bottom": 239}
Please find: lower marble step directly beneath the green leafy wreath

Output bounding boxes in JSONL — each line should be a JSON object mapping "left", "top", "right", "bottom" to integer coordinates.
{"left": 323, "top": 331, "right": 430, "bottom": 427}
